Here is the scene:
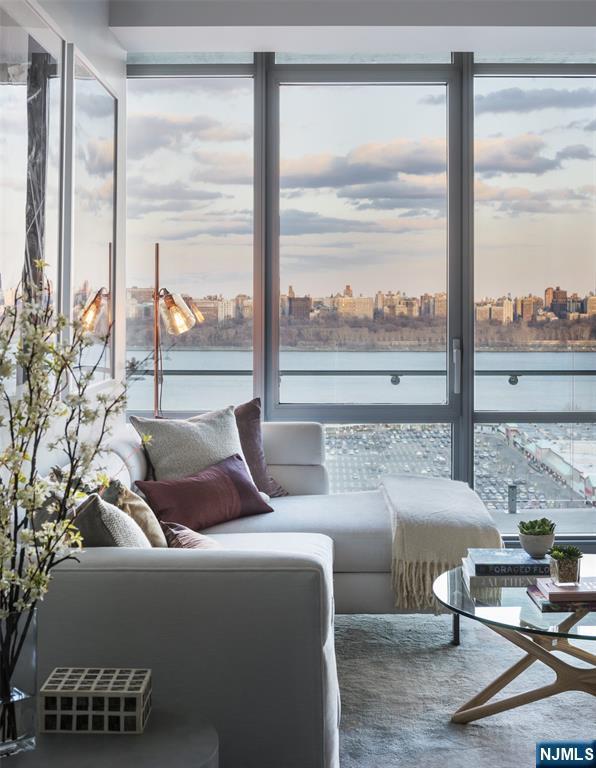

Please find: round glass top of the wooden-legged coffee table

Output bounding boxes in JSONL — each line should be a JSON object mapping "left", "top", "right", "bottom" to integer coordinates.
{"left": 433, "top": 555, "right": 596, "bottom": 640}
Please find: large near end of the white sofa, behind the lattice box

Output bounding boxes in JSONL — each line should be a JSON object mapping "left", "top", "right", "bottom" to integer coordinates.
{"left": 38, "top": 534, "right": 338, "bottom": 768}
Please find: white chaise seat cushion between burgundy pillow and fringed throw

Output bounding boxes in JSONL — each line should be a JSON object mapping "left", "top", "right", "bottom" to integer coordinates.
{"left": 204, "top": 491, "right": 392, "bottom": 573}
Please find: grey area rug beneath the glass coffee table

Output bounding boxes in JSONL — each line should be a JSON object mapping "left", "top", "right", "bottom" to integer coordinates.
{"left": 336, "top": 616, "right": 596, "bottom": 768}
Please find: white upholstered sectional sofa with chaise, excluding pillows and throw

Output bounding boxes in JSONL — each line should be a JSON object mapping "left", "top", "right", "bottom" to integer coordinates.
{"left": 39, "top": 423, "right": 474, "bottom": 768}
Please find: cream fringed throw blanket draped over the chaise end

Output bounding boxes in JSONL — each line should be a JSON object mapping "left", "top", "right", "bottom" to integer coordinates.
{"left": 381, "top": 475, "right": 502, "bottom": 611}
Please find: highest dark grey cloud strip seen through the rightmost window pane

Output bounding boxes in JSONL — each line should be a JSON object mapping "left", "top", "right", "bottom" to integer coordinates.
{"left": 475, "top": 88, "right": 596, "bottom": 114}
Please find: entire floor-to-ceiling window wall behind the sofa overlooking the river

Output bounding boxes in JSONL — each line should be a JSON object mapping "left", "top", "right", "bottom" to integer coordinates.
{"left": 127, "top": 54, "right": 596, "bottom": 533}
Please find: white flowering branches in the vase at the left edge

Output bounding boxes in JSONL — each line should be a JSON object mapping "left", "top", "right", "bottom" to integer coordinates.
{"left": 0, "top": 272, "right": 125, "bottom": 720}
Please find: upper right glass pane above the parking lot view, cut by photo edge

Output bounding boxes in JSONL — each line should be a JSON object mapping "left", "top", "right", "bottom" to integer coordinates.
{"left": 475, "top": 77, "right": 596, "bottom": 411}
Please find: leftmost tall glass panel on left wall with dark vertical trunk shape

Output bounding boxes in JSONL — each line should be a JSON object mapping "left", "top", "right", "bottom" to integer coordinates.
{"left": 0, "top": 10, "right": 61, "bottom": 311}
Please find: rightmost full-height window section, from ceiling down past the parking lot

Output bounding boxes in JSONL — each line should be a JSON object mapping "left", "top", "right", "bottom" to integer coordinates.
{"left": 474, "top": 65, "right": 596, "bottom": 530}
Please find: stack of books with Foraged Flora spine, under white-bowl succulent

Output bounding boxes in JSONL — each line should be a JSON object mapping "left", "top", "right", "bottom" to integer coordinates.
{"left": 462, "top": 549, "right": 550, "bottom": 592}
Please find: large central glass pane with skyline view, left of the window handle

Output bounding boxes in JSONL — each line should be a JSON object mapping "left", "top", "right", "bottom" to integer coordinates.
{"left": 280, "top": 84, "right": 447, "bottom": 404}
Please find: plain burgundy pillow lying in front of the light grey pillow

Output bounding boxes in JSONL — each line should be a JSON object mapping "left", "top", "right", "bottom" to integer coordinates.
{"left": 137, "top": 453, "right": 273, "bottom": 531}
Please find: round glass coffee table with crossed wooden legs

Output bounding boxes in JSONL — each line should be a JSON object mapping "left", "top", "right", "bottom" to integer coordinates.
{"left": 433, "top": 555, "right": 596, "bottom": 723}
